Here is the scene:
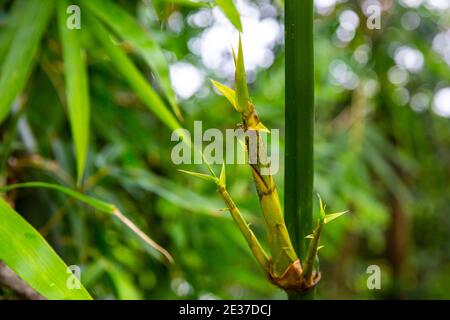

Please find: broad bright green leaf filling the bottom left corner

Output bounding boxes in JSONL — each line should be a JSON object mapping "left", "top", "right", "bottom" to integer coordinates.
{"left": 0, "top": 198, "right": 92, "bottom": 300}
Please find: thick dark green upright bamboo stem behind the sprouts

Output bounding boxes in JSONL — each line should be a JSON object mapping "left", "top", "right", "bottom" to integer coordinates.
{"left": 284, "top": 0, "right": 314, "bottom": 298}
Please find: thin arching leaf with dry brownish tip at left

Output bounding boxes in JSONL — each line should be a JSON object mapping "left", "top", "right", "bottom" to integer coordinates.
{"left": 0, "top": 182, "right": 173, "bottom": 263}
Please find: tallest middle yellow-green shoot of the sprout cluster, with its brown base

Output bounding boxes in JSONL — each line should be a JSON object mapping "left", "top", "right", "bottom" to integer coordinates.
{"left": 212, "top": 38, "right": 302, "bottom": 289}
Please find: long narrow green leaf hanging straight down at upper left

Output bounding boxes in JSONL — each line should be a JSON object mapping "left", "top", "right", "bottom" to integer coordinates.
{"left": 58, "top": 0, "right": 90, "bottom": 184}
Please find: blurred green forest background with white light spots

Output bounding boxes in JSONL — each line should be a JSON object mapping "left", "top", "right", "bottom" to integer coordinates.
{"left": 0, "top": 0, "right": 450, "bottom": 299}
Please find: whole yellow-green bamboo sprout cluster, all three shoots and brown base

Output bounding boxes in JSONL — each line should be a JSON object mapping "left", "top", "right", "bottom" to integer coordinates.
{"left": 180, "top": 38, "right": 345, "bottom": 294}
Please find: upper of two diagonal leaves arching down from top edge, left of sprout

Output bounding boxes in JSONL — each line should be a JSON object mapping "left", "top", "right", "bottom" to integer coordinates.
{"left": 82, "top": 0, "right": 181, "bottom": 119}
